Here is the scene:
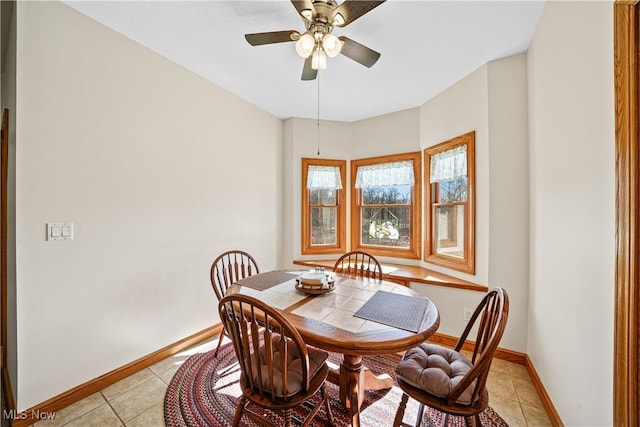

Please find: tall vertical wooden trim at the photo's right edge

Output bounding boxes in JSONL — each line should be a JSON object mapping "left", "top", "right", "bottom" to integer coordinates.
{"left": 613, "top": 0, "right": 640, "bottom": 426}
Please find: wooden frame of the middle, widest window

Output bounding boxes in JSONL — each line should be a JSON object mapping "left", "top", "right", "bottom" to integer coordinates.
{"left": 351, "top": 151, "right": 422, "bottom": 259}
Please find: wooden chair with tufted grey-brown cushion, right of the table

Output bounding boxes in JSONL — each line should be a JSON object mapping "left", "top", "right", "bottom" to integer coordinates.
{"left": 393, "top": 288, "right": 509, "bottom": 427}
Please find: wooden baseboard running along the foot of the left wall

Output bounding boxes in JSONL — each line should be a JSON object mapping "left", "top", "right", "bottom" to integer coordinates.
{"left": 12, "top": 324, "right": 222, "bottom": 427}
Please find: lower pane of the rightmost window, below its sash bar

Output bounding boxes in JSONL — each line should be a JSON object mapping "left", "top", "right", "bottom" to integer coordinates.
{"left": 434, "top": 205, "right": 464, "bottom": 259}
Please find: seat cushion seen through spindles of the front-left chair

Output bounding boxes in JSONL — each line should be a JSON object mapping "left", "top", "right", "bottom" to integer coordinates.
{"left": 253, "top": 336, "right": 329, "bottom": 398}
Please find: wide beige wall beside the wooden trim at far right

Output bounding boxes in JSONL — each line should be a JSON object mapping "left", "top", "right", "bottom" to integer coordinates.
{"left": 527, "top": 1, "right": 615, "bottom": 426}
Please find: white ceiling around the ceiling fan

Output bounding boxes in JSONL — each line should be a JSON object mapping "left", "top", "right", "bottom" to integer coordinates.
{"left": 65, "top": 0, "right": 544, "bottom": 122}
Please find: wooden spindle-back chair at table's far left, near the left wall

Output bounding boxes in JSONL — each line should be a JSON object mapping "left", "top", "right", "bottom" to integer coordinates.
{"left": 211, "top": 250, "right": 260, "bottom": 356}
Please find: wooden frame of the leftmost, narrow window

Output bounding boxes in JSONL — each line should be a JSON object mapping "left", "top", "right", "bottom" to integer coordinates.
{"left": 301, "top": 158, "right": 347, "bottom": 255}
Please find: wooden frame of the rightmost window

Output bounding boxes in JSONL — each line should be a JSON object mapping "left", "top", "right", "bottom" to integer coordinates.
{"left": 424, "top": 131, "right": 476, "bottom": 274}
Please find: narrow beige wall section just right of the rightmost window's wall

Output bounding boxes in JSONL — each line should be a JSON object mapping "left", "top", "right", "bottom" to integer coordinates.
{"left": 487, "top": 55, "right": 529, "bottom": 353}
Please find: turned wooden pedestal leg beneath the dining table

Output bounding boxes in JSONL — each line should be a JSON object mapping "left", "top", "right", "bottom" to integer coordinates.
{"left": 340, "top": 354, "right": 393, "bottom": 427}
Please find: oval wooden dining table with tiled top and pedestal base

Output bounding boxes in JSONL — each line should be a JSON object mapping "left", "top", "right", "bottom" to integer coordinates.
{"left": 227, "top": 270, "right": 440, "bottom": 427}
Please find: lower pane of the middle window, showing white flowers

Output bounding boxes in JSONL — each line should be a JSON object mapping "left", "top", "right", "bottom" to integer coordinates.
{"left": 360, "top": 207, "right": 411, "bottom": 248}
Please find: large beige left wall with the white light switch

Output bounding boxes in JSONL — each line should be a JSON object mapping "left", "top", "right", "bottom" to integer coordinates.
{"left": 17, "top": 2, "right": 282, "bottom": 410}
